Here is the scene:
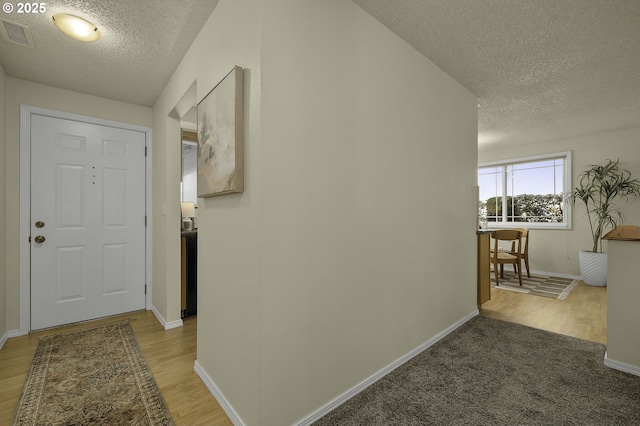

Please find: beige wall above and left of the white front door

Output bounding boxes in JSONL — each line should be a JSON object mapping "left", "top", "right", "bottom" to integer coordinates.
{"left": 6, "top": 77, "right": 151, "bottom": 330}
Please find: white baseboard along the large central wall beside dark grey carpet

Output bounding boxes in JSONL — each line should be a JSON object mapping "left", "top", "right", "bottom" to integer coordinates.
{"left": 295, "top": 309, "right": 479, "bottom": 426}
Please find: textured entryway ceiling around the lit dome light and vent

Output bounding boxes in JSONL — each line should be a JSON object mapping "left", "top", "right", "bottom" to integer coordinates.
{"left": 0, "top": 0, "right": 218, "bottom": 106}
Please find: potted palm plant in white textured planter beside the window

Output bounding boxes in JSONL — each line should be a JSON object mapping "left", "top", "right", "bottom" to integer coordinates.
{"left": 570, "top": 160, "right": 640, "bottom": 286}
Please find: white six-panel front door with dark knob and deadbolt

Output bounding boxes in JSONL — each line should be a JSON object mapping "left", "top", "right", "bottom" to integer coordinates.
{"left": 31, "top": 115, "right": 146, "bottom": 330}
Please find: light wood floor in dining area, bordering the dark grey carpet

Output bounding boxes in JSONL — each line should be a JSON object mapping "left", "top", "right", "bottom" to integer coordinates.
{"left": 480, "top": 281, "right": 607, "bottom": 344}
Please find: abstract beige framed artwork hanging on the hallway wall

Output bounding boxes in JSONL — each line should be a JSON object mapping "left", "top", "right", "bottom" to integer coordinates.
{"left": 198, "top": 66, "right": 244, "bottom": 197}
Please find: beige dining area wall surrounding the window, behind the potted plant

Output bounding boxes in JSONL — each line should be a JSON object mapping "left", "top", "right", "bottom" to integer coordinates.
{"left": 479, "top": 128, "right": 640, "bottom": 275}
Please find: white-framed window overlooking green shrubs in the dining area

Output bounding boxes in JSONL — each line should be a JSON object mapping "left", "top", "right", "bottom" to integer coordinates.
{"left": 478, "top": 152, "right": 571, "bottom": 229}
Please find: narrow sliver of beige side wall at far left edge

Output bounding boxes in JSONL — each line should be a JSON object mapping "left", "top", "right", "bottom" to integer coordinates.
{"left": 0, "top": 66, "right": 8, "bottom": 338}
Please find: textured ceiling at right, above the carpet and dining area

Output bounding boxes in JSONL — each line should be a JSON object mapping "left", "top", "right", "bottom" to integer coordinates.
{"left": 353, "top": 0, "right": 640, "bottom": 149}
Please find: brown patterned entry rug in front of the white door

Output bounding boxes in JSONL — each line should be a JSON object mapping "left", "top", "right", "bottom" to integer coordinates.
{"left": 14, "top": 322, "right": 175, "bottom": 426}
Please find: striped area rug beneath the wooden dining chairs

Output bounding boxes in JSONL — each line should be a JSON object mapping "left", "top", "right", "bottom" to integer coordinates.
{"left": 491, "top": 267, "right": 578, "bottom": 300}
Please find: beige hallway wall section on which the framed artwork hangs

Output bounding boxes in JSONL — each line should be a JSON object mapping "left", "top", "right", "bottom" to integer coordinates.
{"left": 153, "top": 0, "right": 261, "bottom": 424}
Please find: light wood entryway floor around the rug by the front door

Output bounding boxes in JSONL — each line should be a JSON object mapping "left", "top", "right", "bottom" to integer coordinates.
{"left": 0, "top": 311, "right": 232, "bottom": 426}
